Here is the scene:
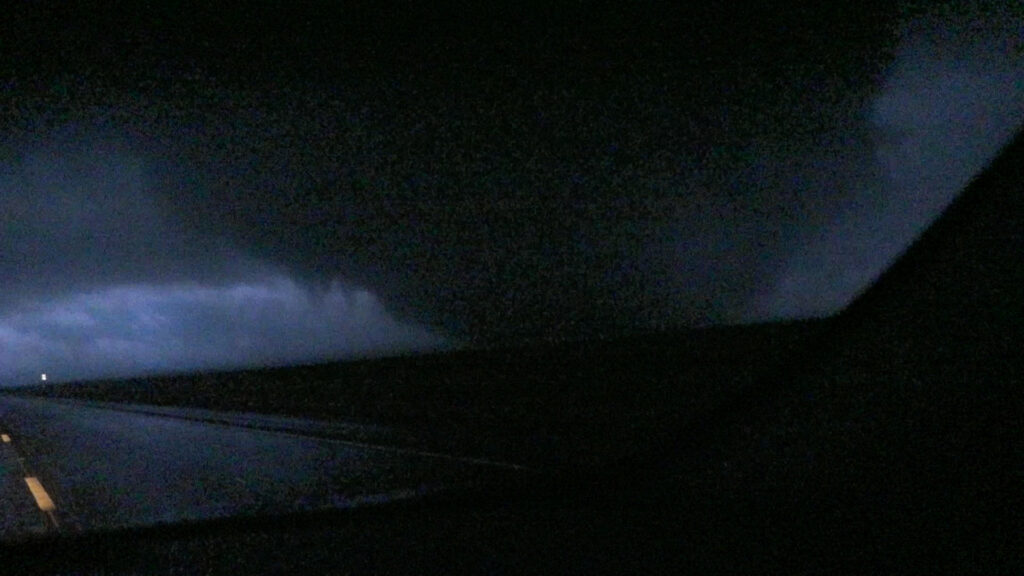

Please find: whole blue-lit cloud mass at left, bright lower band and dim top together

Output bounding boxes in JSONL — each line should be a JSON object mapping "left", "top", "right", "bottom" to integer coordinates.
{"left": 0, "top": 126, "right": 443, "bottom": 383}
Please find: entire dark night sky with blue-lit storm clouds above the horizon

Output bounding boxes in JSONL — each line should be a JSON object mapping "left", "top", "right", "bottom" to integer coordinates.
{"left": 0, "top": 0, "right": 1024, "bottom": 384}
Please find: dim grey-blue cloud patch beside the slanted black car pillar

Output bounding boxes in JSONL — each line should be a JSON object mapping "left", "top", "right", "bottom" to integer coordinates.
{"left": 753, "top": 6, "right": 1024, "bottom": 318}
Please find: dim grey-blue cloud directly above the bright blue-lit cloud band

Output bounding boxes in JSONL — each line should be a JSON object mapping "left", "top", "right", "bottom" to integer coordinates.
{"left": 0, "top": 131, "right": 255, "bottom": 304}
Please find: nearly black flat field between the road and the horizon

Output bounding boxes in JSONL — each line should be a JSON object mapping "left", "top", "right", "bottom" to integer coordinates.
{"left": 6, "top": 322, "right": 824, "bottom": 466}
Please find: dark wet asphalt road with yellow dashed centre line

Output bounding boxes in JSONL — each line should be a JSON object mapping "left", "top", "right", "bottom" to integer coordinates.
{"left": 0, "top": 397, "right": 517, "bottom": 540}
